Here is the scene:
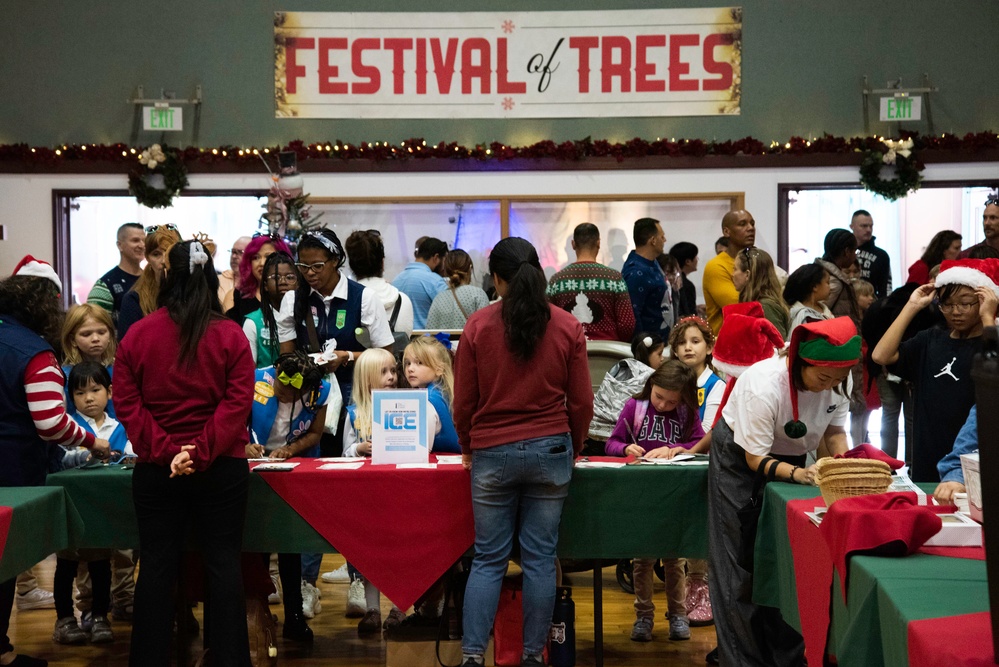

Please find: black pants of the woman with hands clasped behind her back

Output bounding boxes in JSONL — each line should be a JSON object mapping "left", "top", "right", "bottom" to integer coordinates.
{"left": 128, "top": 457, "right": 250, "bottom": 667}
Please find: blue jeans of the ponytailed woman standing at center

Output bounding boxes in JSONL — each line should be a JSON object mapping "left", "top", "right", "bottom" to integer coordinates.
{"left": 461, "top": 434, "right": 573, "bottom": 655}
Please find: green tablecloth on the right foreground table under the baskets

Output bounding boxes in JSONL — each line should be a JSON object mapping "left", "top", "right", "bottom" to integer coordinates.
{"left": 753, "top": 484, "right": 989, "bottom": 667}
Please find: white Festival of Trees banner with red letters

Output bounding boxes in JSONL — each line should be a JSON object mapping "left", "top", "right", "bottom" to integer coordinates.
{"left": 274, "top": 7, "right": 742, "bottom": 118}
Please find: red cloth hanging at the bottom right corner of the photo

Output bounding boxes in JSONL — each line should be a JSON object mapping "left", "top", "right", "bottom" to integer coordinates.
{"left": 908, "top": 611, "right": 995, "bottom": 667}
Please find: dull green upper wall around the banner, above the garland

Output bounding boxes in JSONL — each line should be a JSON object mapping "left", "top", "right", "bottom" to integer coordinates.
{"left": 0, "top": 0, "right": 999, "bottom": 146}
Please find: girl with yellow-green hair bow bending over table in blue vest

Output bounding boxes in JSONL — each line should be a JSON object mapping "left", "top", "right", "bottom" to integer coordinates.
{"left": 246, "top": 352, "right": 331, "bottom": 641}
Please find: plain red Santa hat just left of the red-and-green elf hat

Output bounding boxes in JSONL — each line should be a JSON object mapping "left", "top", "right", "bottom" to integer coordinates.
{"left": 711, "top": 301, "right": 784, "bottom": 377}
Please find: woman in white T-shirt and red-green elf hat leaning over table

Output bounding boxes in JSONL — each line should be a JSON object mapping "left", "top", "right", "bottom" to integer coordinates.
{"left": 708, "top": 317, "right": 860, "bottom": 667}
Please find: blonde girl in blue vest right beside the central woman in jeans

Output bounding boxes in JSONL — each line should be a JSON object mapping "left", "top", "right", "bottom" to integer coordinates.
{"left": 402, "top": 336, "right": 461, "bottom": 454}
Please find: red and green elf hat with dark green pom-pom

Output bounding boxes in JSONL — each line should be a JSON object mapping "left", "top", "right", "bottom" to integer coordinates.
{"left": 784, "top": 317, "right": 861, "bottom": 438}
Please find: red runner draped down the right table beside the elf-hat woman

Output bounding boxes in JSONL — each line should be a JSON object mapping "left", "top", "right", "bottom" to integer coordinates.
{"left": 787, "top": 498, "right": 985, "bottom": 665}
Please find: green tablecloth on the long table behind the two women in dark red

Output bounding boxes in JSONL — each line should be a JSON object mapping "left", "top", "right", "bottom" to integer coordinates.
{"left": 48, "top": 466, "right": 708, "bottom": 559}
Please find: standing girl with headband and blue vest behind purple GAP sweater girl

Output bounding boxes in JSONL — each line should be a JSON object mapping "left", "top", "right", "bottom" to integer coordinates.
{"left": 669, "top": 317, "right": 725, "bottom": 626}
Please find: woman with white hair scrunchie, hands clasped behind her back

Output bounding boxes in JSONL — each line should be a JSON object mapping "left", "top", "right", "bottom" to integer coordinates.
{"left": 115, "top": 240, "right": 254, "bottom": 667}
